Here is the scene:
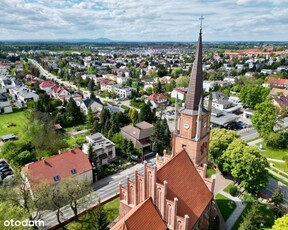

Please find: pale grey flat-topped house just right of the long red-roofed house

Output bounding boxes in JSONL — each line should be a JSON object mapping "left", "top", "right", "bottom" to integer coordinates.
{"left": 82, "top": 133, "right": 116, "bottom": 165}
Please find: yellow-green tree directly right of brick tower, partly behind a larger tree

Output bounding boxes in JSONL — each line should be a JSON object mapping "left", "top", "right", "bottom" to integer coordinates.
{"left": 209, "top": 129, "right": 240, "bottom": 164}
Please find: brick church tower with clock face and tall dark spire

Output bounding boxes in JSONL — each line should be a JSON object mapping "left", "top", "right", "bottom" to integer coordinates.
{"left": 172, "top": 27, "right": 210, "bottom": 166}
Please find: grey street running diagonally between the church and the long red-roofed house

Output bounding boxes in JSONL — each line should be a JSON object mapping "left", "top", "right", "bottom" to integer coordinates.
{"left": 40, "top": 158, "right": 155, "bottom": 229}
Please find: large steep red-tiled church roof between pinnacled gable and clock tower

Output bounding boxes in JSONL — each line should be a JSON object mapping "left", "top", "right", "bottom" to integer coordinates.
{"left": 157, "top": 149, "right": 213, "bottom": 229}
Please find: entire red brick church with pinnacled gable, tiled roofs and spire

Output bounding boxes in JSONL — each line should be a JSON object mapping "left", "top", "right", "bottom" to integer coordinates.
{"left": 112, "top": 30, "right": 215, "bottom": 230}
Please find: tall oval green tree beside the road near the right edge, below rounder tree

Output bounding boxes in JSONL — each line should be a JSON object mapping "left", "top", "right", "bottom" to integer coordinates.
{"left": 251, "top": 100, "right": 277, "bottom": 137}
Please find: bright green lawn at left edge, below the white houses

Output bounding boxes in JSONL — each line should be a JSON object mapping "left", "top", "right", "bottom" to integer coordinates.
{"left": 0, "top": 111, "right": 28, "bottom": 136}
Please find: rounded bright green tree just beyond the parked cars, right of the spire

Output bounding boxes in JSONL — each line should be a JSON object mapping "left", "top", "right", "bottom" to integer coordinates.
{"left": 239, "top": 84, "right": 270, "bottom": 109}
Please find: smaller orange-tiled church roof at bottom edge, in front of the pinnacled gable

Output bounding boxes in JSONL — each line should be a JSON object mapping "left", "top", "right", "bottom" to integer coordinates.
{"left": 111, "top": 198, "right": 167, "bottom": 230}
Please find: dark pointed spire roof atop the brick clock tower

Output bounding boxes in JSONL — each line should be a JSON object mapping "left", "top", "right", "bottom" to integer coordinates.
{"left": 185, "top": 28, "right": 203, "bottom": 111}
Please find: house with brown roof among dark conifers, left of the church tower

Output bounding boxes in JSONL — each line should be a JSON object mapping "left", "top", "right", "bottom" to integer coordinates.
{"left": 121, "top": 121, "right": 153, "bottom": 152}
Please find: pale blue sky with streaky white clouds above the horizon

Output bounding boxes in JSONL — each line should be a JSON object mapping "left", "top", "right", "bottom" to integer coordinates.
{"left": 0, "top": 0, "right": 288, "bottom": 42}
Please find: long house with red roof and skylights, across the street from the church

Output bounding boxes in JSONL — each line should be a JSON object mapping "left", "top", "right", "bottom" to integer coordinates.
{"left": 22, "top": 149, "right": 93, "bottom": 194}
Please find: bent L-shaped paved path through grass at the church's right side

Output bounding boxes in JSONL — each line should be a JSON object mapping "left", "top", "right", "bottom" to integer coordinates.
{"left": 219, "top": 191, "right": 246, "bottom": 230}
